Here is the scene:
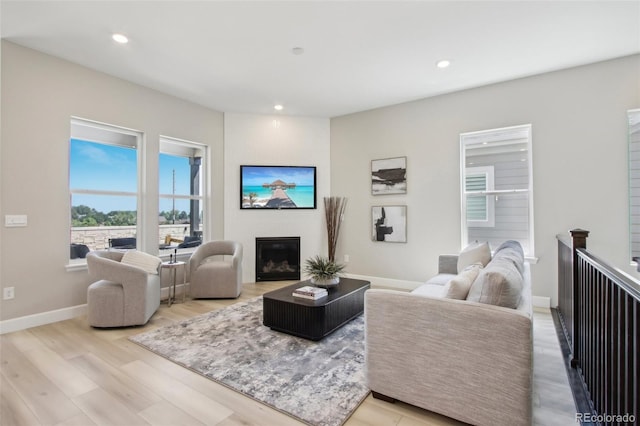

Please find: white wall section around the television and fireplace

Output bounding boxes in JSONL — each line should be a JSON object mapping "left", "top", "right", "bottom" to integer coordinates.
{"left": 224, "top": 113, "right": 330, "bottom": 282}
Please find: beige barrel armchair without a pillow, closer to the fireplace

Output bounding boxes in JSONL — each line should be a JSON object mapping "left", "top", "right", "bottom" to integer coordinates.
{"left": 189, "top": 241, "right": 242, "bottom": 299}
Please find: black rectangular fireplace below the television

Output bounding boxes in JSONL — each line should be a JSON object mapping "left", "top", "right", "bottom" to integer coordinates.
{"left": 256, "top": 237, "right": 300, "bottom": 281}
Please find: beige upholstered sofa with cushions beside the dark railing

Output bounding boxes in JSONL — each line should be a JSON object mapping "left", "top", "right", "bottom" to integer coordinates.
{"left": 365, "top": 241, "right": 533, "bottom": 426}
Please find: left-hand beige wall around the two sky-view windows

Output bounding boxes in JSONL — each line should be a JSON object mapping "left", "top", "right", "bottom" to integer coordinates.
{"left": 0, "top": 41, "right": 223, "bottom": 320}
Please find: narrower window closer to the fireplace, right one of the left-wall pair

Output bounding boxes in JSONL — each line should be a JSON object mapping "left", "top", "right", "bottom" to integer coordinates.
{"left": 158, "top": 136, "right": 206, "bottom": 252}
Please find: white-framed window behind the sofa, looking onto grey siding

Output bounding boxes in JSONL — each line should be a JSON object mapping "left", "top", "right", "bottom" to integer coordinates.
{"left": 460, "top": 125, "right": 534, "bottom": 257}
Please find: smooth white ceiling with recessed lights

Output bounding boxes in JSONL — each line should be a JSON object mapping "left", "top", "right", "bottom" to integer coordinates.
{"left": 0, "top": 0, "right": 640, "bottom": 117}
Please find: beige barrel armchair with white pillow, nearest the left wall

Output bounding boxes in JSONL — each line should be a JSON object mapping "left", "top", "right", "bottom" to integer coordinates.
{"left": 87, "top": 251, "right": 160, "bottom": 327}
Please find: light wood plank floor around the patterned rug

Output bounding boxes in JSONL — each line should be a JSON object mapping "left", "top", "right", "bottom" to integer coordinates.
{"left": 0, "top": 282, "right": 575, "bottom": 426}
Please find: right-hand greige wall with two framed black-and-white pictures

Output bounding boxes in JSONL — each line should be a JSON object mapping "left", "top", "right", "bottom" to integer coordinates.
{"left": 331, "top": 55, "right": 640, "bottom": 306}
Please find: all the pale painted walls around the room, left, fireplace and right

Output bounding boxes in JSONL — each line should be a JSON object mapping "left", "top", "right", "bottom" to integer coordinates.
{"left": 0, "top": 41, "right": 640, "bottom": 326}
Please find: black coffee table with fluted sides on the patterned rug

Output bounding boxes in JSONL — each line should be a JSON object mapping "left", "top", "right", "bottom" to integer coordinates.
{"left": 262, "top": 278, "right": 371, "bottom": 340}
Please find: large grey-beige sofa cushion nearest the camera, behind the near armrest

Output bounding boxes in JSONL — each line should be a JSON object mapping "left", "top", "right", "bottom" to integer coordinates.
{"left": 467, "top": 258, "right": 523, "bottom": 309}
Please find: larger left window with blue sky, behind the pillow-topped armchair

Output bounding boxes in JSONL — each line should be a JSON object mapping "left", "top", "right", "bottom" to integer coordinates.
{"left": 69, "top": 118, "right": 142, "bottom": 262}
